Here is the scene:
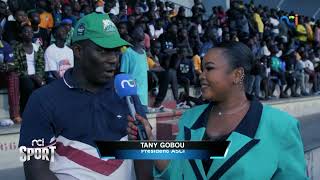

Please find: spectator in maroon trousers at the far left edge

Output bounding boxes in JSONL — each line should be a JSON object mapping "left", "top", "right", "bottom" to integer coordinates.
{"left": 0, "top": 27, "right": 22, "bottom": 123}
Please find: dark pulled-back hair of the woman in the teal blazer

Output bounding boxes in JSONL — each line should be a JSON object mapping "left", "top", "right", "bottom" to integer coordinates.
{"left": 215, "top": 41, "right": 254, "bottom": 76}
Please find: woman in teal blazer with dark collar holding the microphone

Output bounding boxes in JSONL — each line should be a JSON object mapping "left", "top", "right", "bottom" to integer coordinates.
{"left": 128, "top": 42, "right": 308, "bottom": 180}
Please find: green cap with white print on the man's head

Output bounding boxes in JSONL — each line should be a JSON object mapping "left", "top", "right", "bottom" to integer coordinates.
{"left": 72, "top": 13, "right": 131, "bottom": 49}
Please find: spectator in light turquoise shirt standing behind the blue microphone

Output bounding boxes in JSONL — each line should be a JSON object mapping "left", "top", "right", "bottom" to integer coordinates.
{"left": 120, "top": 25, "right": 148, "bottom": 112}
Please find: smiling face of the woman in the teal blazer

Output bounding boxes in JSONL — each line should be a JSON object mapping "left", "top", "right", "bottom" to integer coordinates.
{"left": 200, "top": 48, "right": 235, "bottom": 102}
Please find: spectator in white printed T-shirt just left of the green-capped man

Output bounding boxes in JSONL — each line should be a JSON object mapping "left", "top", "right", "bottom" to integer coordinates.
{"left": 44, "top": 25, "right": 74, "bottom": 83}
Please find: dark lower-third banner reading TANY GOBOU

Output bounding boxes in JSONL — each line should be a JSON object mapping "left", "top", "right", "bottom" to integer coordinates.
{"left": 96, "top": 141, "right": 230, "bottom": 160}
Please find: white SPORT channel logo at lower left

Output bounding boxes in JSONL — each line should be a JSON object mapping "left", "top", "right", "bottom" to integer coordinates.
{"left": 19, "top": 138, "right": 56, "bottom": 162}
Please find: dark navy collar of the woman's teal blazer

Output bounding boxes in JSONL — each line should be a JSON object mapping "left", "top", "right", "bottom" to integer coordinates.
{"left": 191, "top": 95, "right": 263, "bottom": 138}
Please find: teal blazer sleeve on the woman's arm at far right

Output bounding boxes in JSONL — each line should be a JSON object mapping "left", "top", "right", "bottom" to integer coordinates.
{"left": 272, "top": 117, "right": 308, "bottom": 180}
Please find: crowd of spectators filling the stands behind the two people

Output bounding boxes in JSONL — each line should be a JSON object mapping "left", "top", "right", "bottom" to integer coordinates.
{"left": 0, "top": 0, "right": 320, "bottom": 123}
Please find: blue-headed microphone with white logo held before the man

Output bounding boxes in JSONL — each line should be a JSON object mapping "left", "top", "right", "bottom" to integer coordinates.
{"left": 114, "top": 74, "right": 148, "bottom": 140}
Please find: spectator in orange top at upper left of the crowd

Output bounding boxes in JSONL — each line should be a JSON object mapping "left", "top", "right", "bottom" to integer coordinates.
{"left": 37, "top": 0, "right": 54, "bottom": 30}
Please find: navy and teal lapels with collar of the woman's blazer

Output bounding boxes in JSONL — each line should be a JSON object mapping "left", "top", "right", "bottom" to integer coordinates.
{"left": 184, "top": 96, "right": 263, "bottom": 180}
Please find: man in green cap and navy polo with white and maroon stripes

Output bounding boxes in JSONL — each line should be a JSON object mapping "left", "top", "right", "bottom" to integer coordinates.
{"left": 20, "top": 13, "right": 145, "bottom": 180}
